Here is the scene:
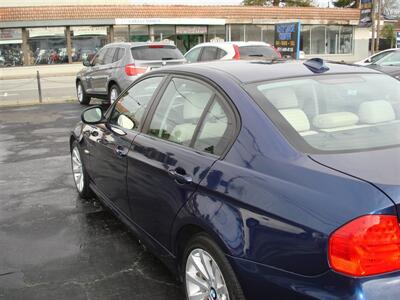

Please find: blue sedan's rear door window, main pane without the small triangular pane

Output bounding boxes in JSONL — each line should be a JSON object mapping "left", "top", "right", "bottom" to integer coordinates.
{"left": 149, "top": 78, "right": 215, "bottom": 146}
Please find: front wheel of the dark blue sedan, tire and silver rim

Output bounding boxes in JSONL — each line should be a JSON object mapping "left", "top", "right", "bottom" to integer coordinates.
{"left": 71, "top": 141, "right": 92, "bottom": 199}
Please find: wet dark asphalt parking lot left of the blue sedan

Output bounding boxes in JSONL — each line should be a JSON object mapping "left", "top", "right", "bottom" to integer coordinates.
{"left": 0, "top": 103, "right": 184, "bottom": 300}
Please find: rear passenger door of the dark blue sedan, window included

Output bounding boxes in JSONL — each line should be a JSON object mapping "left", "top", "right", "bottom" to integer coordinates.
{"left": 127, "top": 76, "right": 234, "bottom": 245}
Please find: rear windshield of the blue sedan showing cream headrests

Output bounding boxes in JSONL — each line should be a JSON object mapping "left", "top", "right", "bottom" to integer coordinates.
{"left": 248, "top": 74, "right": 400, "bottom": 152}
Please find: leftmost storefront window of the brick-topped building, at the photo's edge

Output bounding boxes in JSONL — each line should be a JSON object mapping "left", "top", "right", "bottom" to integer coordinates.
{"left": 0, "top": 29, "right": 23, "bottom": 67}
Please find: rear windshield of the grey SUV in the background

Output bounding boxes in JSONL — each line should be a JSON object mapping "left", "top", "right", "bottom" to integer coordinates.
{"left": 131, "top": 45, "right": 184, "bottom": 60}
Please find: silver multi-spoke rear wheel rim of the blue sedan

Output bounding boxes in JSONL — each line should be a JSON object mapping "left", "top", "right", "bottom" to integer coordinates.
{"left": 185, "top": 249, "right": 229, "bottom": 300}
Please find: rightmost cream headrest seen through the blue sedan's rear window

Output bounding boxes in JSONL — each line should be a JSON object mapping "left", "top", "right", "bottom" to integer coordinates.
{"left": 358, "top": 100, "right": 396, "bottom": 124}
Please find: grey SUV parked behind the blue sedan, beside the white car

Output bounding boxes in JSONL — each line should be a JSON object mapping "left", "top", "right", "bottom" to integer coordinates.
{"left": 76, "top": 43, "right": 186, "bottom": 105}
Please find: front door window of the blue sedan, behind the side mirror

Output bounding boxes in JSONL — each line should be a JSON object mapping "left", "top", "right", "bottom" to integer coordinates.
{"left": 110, "top": 77, "right": 163, "bottom": 129}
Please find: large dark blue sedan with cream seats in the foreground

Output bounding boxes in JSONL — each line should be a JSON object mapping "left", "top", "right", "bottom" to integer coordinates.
{"left": 70, "top": 59, "right": 400, "bottom": 300}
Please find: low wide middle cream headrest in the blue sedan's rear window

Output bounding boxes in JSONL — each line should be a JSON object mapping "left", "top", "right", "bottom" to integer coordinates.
{"left": 313, "top": 111, "right": 359, "bottom": 129}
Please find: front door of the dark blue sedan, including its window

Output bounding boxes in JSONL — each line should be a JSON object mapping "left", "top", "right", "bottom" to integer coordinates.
{"left": 89, "top": 76, "right": 163, "bottom": 216}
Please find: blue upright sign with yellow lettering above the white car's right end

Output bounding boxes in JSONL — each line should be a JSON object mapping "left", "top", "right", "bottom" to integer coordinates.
{"left": 275, "top": 22, "right": 300, "bottom": 59}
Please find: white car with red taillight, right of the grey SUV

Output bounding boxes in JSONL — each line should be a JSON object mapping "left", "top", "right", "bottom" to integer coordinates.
{"left": 185, "top": 42, "right": 282, "bottom": 62}
